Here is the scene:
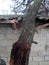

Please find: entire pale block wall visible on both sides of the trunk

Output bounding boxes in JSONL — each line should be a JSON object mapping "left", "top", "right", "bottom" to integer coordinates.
{"left": 0, "top": 27, "right": 49, "bottom": 65}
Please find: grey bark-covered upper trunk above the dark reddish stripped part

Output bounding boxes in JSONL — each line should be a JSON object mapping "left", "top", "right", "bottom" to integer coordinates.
{"left": 19, "top": 0, "right": 42, "bottom": 45}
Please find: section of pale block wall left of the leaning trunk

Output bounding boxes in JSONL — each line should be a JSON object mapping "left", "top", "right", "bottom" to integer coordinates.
{"left": 0, "top": 27, "right": 21, "bottom": 63}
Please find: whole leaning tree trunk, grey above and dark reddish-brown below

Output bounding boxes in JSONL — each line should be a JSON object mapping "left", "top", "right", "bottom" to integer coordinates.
{"left": 10, "top": 0, "right": 42, "bottom": 65}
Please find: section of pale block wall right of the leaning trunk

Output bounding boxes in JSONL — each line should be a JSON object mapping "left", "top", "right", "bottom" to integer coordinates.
{"left": 29, "top": 28, "right": 49, "bottom": 65}
